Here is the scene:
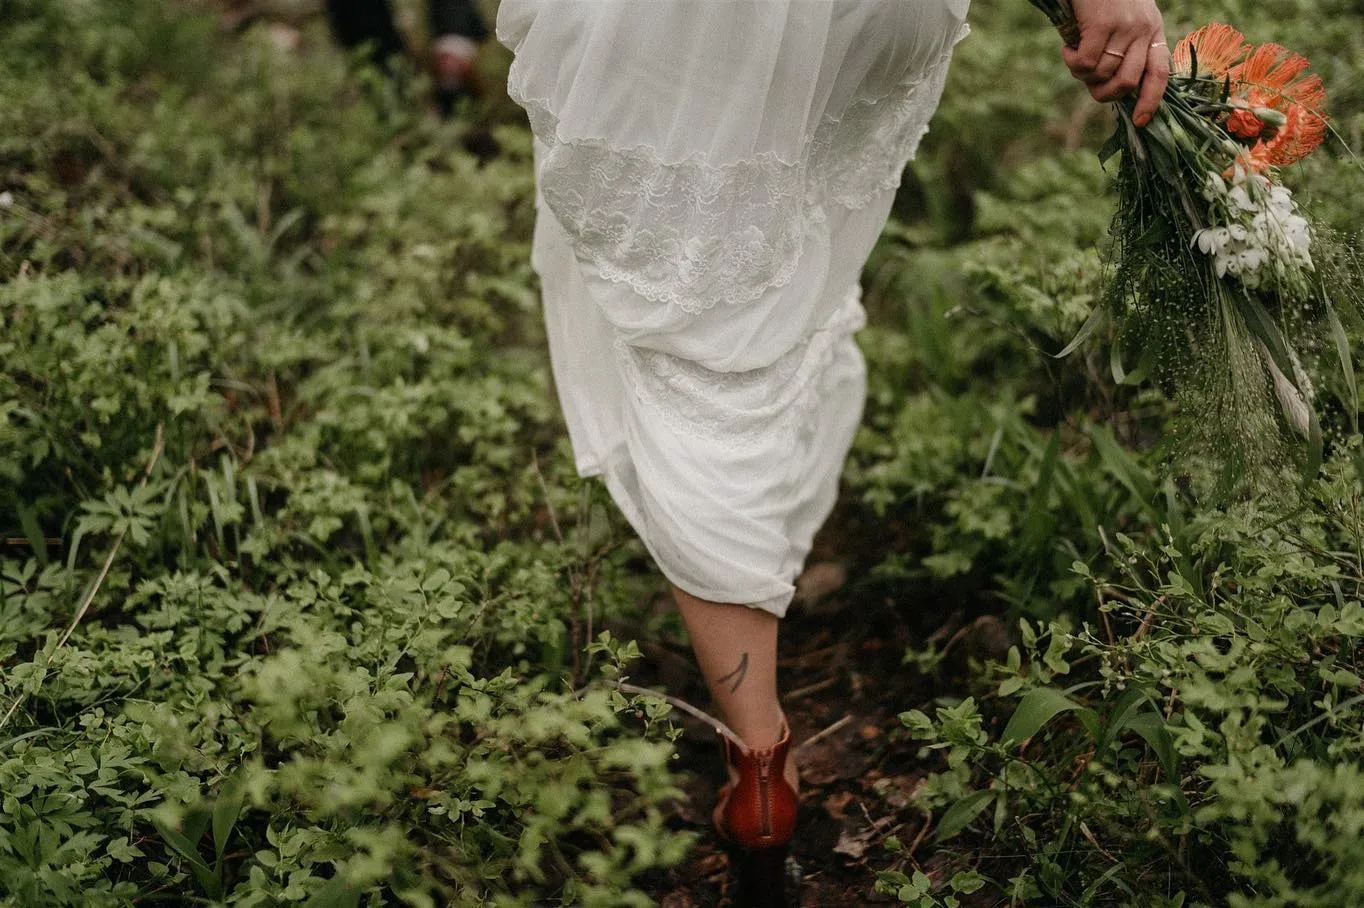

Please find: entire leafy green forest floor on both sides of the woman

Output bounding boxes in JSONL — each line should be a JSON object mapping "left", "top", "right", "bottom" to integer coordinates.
{"left": 8, "top": 0, "right": 1364, "bottom": 908}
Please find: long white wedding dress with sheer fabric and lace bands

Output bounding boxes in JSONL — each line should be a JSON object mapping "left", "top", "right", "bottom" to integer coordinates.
{"left": 498, "top": 0, "right": 967, "bottom": 616}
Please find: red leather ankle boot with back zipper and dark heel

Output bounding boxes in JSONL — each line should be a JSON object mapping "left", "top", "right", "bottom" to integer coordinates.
{"left": 713, "top": 717, "right": 798, "bottom": 908}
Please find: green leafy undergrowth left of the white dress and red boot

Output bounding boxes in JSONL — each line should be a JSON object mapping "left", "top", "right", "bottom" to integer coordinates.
{"left": 0, "top": 0, "right": 679, "bottom": 908}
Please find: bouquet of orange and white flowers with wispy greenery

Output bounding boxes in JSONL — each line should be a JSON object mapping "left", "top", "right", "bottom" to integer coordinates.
{"left": 1030, "top": 0, "right": 1361, "bottom": 488}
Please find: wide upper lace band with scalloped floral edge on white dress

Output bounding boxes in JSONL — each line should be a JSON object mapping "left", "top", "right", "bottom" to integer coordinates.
{"left": 507, "top": 23, "right": 968, "bottom": 314}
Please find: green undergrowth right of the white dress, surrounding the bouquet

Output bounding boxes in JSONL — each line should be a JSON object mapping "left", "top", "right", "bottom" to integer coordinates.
{"left": 847, "top": 1, "right": 1364, "bottom": 907}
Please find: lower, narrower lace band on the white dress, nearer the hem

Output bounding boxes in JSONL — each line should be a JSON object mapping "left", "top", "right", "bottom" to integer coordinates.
{"left": 615, "top": 288, "right": 866, "bottom": 451}
